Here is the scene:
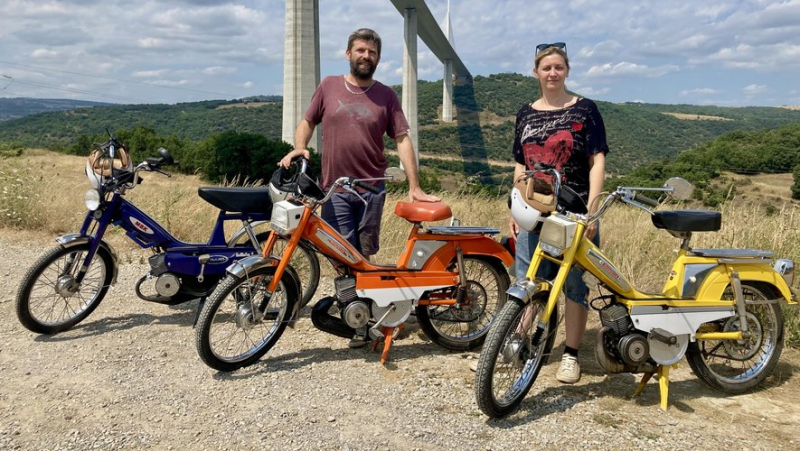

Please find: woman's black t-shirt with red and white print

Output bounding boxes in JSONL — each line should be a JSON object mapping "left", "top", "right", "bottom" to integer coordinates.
{"left": 512, "top": 98, "right": 608, "bottom": 202}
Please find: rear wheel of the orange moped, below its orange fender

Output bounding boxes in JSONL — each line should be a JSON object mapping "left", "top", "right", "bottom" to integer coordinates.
{"left": 416, "top": 256, "right": 510, "bottom": 351}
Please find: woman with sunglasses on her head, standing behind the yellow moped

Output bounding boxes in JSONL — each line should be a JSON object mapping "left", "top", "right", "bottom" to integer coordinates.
{"left": 509, "top": 42, "right": 608, "bottom": 384}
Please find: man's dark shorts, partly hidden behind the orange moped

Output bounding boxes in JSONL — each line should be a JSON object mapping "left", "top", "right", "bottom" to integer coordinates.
{"left": 322, "top": 191, "right": 386, "bottom": 257}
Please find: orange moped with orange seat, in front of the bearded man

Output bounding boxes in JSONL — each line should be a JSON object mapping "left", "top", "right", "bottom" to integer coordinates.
{"left": 196, "top": 159, "right": 513, "bottom": 371}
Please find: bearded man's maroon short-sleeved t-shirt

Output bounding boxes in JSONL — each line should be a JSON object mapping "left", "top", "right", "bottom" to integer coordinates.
{"left": 303, "top": 75, "right": 409, "bottom": 189}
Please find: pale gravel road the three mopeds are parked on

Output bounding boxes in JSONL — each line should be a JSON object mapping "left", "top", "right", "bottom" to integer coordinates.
{"left": 0, "top": 231, "right": 800, "bottom": 450}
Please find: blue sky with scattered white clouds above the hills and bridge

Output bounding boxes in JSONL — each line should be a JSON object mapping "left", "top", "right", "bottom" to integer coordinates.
{"left": 0, "top": 0, "right": 800, "bottom": 106}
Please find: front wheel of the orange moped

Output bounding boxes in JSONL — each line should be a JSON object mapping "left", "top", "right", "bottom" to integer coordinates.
{"left": 195, "top": 267, "right": 299, "bottom": 371}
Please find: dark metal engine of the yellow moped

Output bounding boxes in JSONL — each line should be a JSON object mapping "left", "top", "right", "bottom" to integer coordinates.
{"left": 595, "top": 304, "right": 651, "bottom": 373}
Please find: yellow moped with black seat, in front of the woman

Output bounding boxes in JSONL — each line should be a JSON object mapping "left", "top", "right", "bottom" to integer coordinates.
{"left": 475, "top": 167, "right": 800, "bottom": 417}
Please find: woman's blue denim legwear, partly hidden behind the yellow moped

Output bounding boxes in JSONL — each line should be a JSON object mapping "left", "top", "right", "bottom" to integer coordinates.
{"left": 514, "top": 226, "right": 600, "bottom": 309}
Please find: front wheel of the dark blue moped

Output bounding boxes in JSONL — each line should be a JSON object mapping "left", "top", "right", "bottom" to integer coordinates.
{"left": 16, "top": 243, "right": 114, "bottom": 335}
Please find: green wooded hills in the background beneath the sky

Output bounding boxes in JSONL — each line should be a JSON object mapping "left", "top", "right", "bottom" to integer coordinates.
{"left": 0, "top": 74, "right": 800, "bottom": 174}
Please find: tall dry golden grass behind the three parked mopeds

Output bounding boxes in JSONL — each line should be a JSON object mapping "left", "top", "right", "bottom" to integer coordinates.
{"left": 0, "top": 150, "right": 800, "bottom": 343}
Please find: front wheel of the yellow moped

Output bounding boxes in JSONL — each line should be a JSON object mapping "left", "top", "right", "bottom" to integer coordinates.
{"left": 475, "top": 293, "right": 558, "bottom": 418}
